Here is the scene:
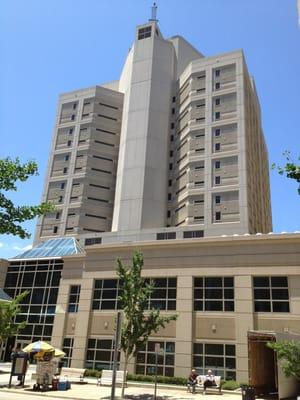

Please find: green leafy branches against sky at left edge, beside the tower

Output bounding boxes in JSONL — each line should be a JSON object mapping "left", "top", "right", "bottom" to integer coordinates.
{"left": 0, "top": 158, "right": 54, "bottom": 239}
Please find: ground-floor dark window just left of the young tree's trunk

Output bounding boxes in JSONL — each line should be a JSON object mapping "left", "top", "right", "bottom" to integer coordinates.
{"left": 85, "top": 338, "right": 120, "bottom": 370}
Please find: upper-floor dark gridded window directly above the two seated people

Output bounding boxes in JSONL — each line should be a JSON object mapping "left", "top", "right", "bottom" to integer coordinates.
{"left": 194, "top": 277, "right": 234, "bottom": 311}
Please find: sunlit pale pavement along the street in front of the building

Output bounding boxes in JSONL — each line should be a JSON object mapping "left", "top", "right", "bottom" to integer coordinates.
{"left": 0, "top": 363, "right": 242, "bottom": 400}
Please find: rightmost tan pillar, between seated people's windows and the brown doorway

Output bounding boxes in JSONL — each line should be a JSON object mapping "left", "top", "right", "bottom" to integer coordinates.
{"left": 234, "top": 276, "right": 254, "bottom": 382}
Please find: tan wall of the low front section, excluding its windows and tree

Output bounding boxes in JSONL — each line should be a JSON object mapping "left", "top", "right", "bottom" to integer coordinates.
{"left": 48, "top": 234, "right": 300, "bottom": 381}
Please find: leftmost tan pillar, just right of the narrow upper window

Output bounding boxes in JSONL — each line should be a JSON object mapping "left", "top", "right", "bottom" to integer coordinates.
{"left": 71, "top": 279, "right": 94, "bottom": 368}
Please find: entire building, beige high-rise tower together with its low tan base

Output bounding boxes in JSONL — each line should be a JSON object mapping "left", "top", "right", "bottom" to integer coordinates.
{"left": 0, "top": 12, "right": 300, "bottom": 398}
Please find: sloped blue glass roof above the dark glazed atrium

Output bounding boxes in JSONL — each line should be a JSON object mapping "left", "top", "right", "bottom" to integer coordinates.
{"left": 12, "top": 237, "right": 85, "bottom": 260}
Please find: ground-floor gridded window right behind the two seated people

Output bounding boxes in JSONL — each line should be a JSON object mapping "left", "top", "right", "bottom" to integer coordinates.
{"left": 193, "top": 343, "right": 236, "bottom": 380}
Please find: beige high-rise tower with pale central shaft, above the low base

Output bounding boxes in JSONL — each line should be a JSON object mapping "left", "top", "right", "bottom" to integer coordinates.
{"left": 36, "top": 20, "right": 272, "bottom": 243}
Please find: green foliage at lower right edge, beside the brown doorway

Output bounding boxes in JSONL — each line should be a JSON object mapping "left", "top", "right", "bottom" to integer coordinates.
{"left": 267, "top": 340, "right": 300, "bottom": 380}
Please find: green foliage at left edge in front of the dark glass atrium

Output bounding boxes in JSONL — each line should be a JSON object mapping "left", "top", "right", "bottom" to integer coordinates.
{"left": 0, "top": 291, "right": 29, "bottom": 347}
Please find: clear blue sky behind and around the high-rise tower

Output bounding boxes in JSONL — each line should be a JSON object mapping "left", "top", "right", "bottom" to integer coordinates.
{"left": 0, "top": 0, "right": 300, "bottom": 258}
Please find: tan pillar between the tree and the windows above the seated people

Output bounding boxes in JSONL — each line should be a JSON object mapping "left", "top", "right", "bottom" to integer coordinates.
{"left": 175, "top": 276, "right": 193, "bottom": 376}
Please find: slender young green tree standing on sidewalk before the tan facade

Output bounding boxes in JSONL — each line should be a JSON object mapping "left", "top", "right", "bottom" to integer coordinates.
{"left": 117, "top": 252, "right": 177, "bottom": 398}
